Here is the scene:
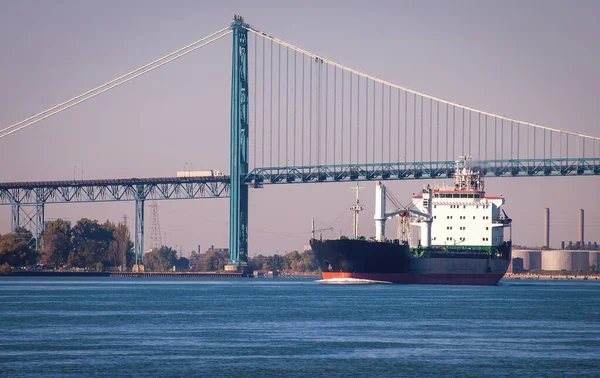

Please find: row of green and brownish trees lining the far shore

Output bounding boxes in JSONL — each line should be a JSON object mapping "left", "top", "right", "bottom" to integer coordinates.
{"left": 0, "top": 218, "right": 318, "bottom": 273}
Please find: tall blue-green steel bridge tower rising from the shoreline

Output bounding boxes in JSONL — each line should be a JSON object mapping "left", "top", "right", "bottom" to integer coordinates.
{"left": 225, "top": 15, "right": 249, "bottom": 271}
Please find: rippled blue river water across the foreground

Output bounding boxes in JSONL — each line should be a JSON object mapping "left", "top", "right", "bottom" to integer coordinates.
{"left": 0, "top": 277, "right": 600, "bottom": 377}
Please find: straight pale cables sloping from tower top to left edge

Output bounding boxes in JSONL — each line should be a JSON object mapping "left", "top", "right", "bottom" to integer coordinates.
{"left": 0, "top": 26, "right": 232, "bottom": 139}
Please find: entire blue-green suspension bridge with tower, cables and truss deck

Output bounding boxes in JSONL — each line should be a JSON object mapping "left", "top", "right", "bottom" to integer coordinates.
{"left": 0, "top": 16, "right": 600, "bottom": 270}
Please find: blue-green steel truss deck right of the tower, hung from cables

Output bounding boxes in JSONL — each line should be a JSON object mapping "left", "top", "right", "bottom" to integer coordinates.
{"left": 244, "top": 158, "right": 600, "bottom": 187}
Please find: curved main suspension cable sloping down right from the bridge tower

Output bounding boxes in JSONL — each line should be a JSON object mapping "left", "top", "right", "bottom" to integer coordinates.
{"left": 243, "top": 25, "right": 600, "bottom": 141}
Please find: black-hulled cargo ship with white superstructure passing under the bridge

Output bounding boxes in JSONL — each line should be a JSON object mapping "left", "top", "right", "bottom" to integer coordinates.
{"left": 310, "top": 156, "right": 512, "bottom": 285}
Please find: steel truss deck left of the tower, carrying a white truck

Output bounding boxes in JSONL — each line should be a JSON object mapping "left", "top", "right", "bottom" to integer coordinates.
{"left": 0, "top": 176, "right": 229, "bottom": 205}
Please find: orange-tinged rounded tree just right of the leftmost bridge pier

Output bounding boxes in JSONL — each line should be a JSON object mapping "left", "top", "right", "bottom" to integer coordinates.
{"left": 40, "top": 219, "right": 73, "bottom": 269}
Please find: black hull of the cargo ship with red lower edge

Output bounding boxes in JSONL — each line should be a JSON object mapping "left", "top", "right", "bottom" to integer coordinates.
{"left": 311, "top": 239, "right": 510, "bottom": 285}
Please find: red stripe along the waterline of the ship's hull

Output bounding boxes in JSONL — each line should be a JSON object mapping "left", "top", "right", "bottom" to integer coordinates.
{"left": 322, "top": 272, "right": 504, "bottom": 285}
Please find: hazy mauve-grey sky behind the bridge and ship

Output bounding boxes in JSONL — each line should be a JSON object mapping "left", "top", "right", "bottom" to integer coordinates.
{"left": 0, "top": 0, "right": 600, "bottom": 256}
